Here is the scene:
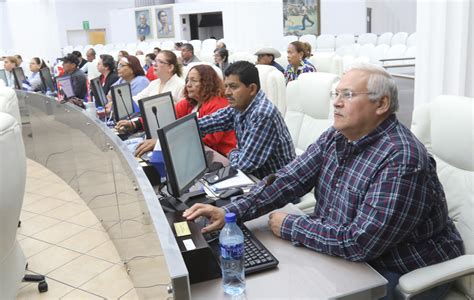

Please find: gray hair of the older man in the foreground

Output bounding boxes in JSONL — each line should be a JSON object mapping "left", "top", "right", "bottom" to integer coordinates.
{"left": 346, "top": 63, "right": 399, "bottom": 113}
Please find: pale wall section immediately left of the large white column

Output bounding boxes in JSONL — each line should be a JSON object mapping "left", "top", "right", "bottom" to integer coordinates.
{"left": 367, "top": 0, "right": 414, "bottom": 34}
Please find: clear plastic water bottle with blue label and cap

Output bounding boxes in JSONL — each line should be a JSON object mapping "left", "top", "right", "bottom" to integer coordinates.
{"left": 219, "top": 213, "right": 245, "bottom": 296}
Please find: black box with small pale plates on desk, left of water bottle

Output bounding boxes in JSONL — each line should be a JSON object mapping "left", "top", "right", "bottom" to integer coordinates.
{"left": 166, "top": 212, "right": 221, "bottom": 284}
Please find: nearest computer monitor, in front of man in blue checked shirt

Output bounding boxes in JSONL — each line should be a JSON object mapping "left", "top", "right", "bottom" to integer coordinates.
{"left": 158, "top": 114, "right": 207, "bottom": 198}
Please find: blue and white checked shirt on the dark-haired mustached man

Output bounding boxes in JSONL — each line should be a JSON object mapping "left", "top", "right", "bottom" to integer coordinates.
{"left": 199, "top": 90, "right": 296, "bottom": 178}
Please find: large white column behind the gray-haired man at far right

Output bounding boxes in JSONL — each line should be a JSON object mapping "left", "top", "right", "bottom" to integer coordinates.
{"left": 415, "top": 0, "right": 474, "bottom": 106}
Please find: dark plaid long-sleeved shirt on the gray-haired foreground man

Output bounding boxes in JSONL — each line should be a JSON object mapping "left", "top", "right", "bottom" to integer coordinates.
{"left": 225, "top": 115, "right": 464, "bottom": 273}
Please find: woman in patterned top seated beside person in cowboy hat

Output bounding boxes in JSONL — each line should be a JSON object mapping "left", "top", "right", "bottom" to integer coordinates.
{"left": 285, "top": 41, "right": 316, "bottom": 84}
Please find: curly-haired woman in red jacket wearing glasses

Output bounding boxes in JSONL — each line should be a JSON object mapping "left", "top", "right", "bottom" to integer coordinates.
{"left": 135, "top": 65, "right": 237, "bottom": 156}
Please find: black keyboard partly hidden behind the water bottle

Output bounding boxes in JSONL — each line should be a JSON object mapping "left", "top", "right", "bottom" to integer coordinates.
{"left": 204, "top": 221, "right": 279, "bottom": 275}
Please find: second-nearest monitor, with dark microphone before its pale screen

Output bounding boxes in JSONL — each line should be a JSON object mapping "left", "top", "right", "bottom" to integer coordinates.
{"left": 138, "top": 92, "right": 176, "bottom": 139}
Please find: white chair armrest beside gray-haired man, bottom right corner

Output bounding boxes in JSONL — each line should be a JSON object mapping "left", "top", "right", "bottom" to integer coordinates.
{"left": 398, "top": 254, "right": 474, "bottom": 294}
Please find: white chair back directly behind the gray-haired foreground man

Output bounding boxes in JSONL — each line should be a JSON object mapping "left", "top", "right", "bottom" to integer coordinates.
{"left": 411, "top": 95, "right": 474, "bottom": 299}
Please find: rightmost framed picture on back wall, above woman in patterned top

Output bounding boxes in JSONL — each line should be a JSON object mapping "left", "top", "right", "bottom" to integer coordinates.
{"left": 283, "top": 0, "right": 321, "bottom": 36}
